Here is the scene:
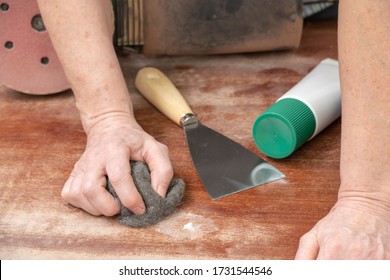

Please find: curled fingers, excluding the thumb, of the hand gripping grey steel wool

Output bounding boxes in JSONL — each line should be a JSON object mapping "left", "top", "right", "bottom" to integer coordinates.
{"left": 61, "top": 151, "right": 145, "bottom": 216}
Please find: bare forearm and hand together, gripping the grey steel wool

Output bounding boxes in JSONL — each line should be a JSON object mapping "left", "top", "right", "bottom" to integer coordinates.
{"left": 38, "top": 0, "right": 173, "bottom": 216}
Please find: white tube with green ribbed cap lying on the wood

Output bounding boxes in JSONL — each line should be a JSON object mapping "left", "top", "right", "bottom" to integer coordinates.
{"left": 253, "top": 58, "right": 341, "bottom": 158}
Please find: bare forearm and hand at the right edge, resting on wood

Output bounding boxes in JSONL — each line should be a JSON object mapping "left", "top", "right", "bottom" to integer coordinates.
{"left": 296, "top": 0, "right": 390, "bottom": 259}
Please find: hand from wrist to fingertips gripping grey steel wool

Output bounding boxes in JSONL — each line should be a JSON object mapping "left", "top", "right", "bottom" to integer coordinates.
{"left": 61, "top": 114, "right": 173, "bottom": 216}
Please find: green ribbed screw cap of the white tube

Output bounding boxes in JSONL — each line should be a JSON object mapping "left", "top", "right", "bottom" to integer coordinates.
{"left": 253, "top": 98, "right": 316, "bottom": 158}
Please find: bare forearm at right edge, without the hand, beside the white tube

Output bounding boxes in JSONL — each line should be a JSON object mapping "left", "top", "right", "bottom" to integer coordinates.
{"left": 339, "top": 0, "right": 390, "bottom": 206}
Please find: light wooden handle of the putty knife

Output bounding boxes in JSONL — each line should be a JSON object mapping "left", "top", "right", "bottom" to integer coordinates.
{"left": 135, "top": 67, "right": 194, "bottom": 126}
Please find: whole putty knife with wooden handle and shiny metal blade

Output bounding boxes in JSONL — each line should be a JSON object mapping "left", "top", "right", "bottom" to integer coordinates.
{"left": 135, "top": 67, "right": 285, "bottom": 199}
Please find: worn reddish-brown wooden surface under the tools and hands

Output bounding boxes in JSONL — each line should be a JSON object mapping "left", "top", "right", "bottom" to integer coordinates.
{"left": 0, "top": 21, "right": 340, "bottom": 259}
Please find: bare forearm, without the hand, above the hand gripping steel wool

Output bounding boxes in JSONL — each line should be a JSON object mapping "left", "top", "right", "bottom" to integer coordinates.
{"left": 38, "top": 0, "right": 133, "bottom": 132}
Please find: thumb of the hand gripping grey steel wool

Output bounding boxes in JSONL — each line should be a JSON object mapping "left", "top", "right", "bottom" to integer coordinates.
{"left": 145, "top": 143, "right": 173, "bottom": 197}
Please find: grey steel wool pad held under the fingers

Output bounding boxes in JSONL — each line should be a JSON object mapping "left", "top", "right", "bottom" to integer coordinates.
{"left": 107, "top": 161, "right": 185, "bottom": 227}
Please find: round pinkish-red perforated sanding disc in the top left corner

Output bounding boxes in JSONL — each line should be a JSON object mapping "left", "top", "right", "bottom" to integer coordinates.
{"left": 0, "top": 0, "right": 69, "bottom": 94}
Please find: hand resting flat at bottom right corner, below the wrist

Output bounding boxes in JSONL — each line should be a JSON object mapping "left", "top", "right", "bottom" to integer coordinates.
{"left": 295, "top": 200, "right": 390, "bottom": 259}
